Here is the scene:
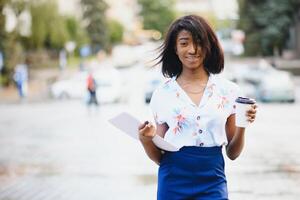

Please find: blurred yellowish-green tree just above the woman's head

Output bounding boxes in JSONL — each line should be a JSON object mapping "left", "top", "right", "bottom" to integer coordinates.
{"left": 138, "top": 0, "right": 176, "bottom": 34}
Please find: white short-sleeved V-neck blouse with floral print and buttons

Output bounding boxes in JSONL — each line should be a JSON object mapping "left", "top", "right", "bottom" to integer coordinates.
{"left": 150, "top": 75, "right": 240, "bottom": 148}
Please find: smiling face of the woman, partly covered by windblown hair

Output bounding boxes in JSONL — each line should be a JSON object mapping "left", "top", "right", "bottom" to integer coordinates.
{"left": 176, "top": 30, "right": 205, "bottom": 69}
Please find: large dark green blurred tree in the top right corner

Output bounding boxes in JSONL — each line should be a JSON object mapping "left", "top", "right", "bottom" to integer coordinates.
{"left": 238, "top": 0, "right": 300, "bottom": 56}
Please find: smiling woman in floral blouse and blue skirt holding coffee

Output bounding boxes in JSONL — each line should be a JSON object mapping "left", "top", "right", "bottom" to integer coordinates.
{"left": 139, "top": 15, "right": 257, "bottom": 200}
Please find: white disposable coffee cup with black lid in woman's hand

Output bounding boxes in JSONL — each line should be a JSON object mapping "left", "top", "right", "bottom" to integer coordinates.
{"left": 235, "top": 97, "right": 255, "bottom": 128}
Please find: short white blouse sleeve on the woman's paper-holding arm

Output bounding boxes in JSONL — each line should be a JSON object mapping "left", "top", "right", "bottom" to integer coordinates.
{"left": 150, "top": 88, "right": 166, "bottom": 124}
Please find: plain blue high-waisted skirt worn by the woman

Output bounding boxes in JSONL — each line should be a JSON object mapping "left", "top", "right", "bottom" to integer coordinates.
{"left": 157, "top": 146, "right": 228, "bottom": 200}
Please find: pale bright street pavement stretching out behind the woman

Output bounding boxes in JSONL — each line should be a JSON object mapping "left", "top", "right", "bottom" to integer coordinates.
{"left": 0, "top": 64, "right": 300, "bottom": 200}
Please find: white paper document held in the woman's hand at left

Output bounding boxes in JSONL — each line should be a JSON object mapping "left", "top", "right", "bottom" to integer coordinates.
{"left": 108, "top": 112, "right": 179, "bottom": 151}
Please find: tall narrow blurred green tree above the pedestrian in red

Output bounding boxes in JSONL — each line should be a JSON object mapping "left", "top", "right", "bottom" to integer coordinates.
{"left": 80, "top": 0, "right": 109, "bottom": 53}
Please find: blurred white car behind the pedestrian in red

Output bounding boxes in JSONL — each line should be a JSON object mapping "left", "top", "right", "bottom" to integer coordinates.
{"left": 51, "top": 68, "right": 121, "bottom": 103}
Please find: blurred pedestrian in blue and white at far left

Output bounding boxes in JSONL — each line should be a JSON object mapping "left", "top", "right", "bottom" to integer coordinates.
{"left": 13, "top": 64, "right": 28, "bottom": 99}
